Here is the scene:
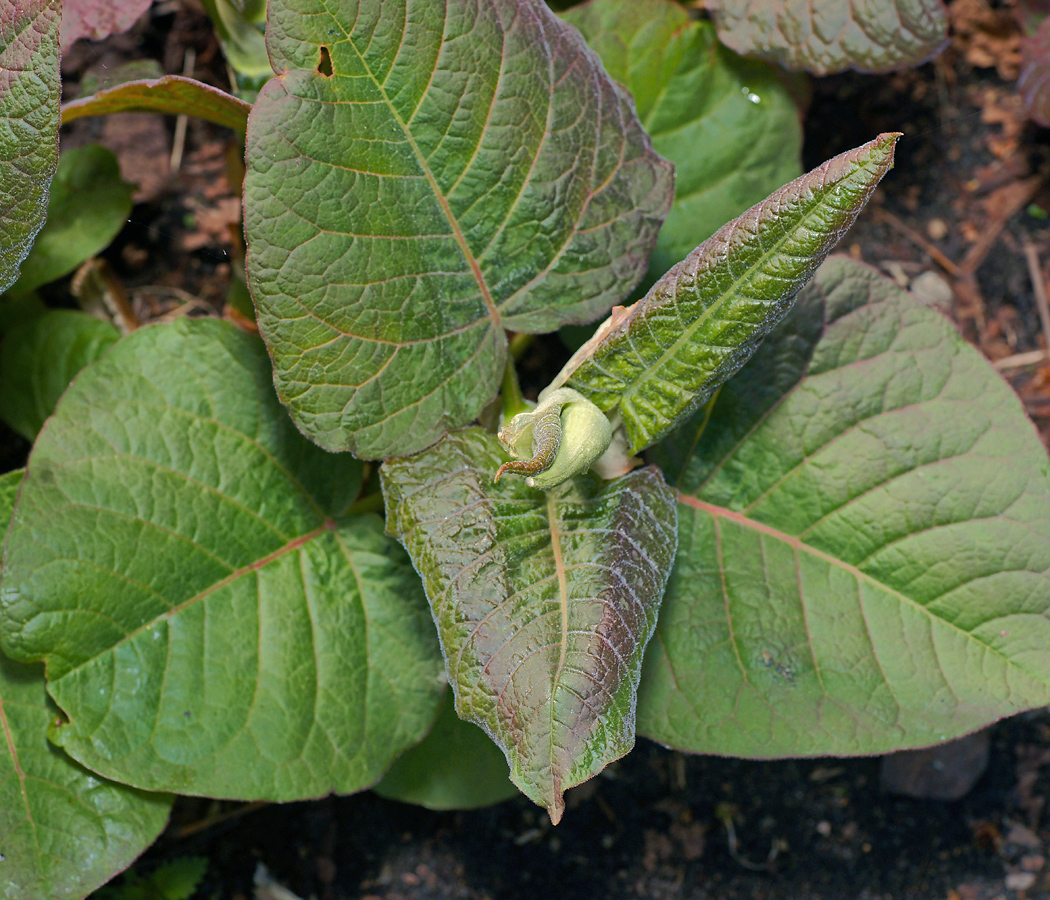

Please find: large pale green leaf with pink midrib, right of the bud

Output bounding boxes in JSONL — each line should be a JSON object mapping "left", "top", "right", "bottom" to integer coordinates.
{"left": 638, "top": 257, "right": 1050, "bottom": 757}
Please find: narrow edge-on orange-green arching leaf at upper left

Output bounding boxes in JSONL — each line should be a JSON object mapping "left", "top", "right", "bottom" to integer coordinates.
{"left": 62, "top": 75, "right": 251, "bottom": 134}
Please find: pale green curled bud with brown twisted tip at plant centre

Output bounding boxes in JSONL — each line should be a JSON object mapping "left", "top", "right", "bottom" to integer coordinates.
{"left": 496, "top": 388, "right": 612, "bottom": 490}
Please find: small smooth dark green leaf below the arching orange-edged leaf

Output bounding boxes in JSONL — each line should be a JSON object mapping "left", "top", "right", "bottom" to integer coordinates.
{"left": 11, "top": 144, "right": 134, "bottom": 294}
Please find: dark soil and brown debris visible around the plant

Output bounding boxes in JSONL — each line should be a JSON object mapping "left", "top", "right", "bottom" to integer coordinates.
{"left": 12, "top": 0, "right": 1050, "bottom": 900}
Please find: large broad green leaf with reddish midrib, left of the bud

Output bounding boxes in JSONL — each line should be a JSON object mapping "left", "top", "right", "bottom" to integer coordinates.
{"left": 0, "top": 319, "right": 442, "bottom": 800}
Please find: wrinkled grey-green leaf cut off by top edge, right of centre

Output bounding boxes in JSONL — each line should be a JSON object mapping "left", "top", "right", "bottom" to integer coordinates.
{"left": 707, "top": 0, "right": 948, "bottom": 75}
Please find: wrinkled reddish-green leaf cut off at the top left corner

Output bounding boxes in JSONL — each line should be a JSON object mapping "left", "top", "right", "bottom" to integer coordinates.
{"left": 0, "top": 0, "right": 62, "bottom": 293}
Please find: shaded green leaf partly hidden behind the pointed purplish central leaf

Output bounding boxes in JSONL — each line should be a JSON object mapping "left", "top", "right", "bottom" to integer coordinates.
{"left": 373, "top": 698, "right": 518, "bottom": 810}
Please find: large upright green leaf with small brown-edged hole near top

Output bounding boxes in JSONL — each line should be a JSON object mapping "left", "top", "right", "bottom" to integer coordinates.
{"left": 245, "top": 0, "right": 672, "bottom": 458}
